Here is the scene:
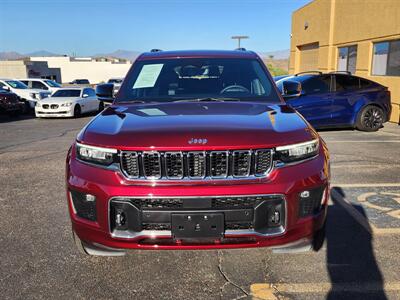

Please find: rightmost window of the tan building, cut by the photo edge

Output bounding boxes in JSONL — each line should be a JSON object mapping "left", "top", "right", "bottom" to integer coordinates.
{"left": 372, "top": 40, "right": 400, "bottom": 76}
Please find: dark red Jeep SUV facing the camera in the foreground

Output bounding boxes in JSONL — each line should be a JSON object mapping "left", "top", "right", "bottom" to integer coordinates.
{"left": 66, "top": 50, "right": 330, "bottom": 255}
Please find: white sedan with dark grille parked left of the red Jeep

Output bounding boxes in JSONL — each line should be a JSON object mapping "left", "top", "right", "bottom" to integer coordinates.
{"left": 35, "top": 87, "right": 104, "bottom": 118}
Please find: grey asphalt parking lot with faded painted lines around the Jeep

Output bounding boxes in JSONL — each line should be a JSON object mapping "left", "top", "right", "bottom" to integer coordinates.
{"left": 0, "top": 116, "right": 400, "bottom": 299}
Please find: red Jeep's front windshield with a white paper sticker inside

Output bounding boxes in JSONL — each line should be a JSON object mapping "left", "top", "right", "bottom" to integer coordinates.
{"left": 116, "top": 58, "right": 281, "bottom": 103}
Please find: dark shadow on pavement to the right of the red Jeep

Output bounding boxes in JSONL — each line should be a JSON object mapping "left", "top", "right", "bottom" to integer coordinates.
{"left": 326, "top": 187, "right": 387, "bottom": 299}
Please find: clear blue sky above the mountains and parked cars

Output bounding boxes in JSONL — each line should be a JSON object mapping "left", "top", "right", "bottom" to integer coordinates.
{"left": 0, "top": 0, "right": 310, "bottom": 55}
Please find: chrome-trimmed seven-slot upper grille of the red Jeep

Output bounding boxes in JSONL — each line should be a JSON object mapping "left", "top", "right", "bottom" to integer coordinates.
{"left": 120, "top": 149, "right": 273, "bottom": 180}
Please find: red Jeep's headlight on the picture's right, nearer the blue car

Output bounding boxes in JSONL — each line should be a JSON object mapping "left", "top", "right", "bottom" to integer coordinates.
{"left": 275, "top": 139, "right": 319, "bottom": 163}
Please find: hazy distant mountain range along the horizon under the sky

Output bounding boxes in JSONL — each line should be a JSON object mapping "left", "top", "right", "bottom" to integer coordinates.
{"left": 0, "top": 49, "right": 290, "bottom": 61}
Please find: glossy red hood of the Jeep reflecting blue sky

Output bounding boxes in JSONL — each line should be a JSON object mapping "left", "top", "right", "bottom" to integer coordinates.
{"left": 78, "top": 102, "right": 316, "bottom": 150}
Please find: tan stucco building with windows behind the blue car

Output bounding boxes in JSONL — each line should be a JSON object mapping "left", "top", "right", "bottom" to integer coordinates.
{"left": 289, "top": 0, "right": 400, "bottom": 123}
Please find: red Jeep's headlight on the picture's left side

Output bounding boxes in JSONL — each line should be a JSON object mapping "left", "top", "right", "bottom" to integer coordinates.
{"left": 76, "top": 143, "right": 118, "bottom": 166}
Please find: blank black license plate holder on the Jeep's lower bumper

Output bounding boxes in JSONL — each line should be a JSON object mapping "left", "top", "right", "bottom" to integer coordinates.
{"left": 171, "top": 213, "right": 224, "bottom": 239}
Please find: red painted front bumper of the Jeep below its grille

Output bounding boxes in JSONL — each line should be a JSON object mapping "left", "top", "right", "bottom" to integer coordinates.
{"left": 66, "top": 147, "right": 329, "bottom": 249}
